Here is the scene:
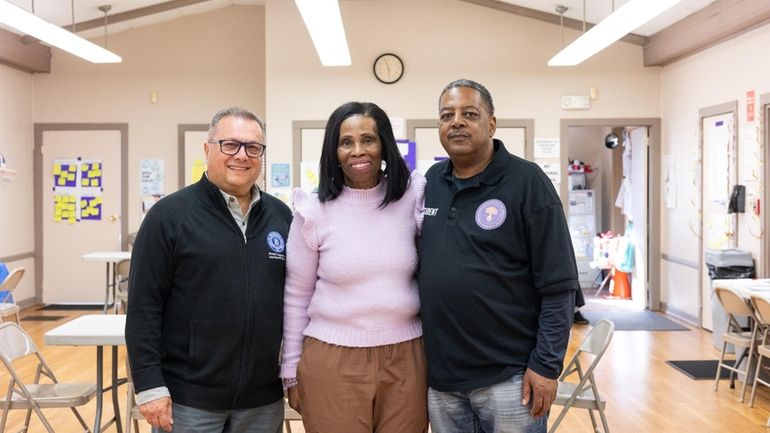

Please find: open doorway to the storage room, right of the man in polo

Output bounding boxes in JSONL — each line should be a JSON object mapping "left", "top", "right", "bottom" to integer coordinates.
{"left": 559, "top": 118, "right": 660, "bottom": 311}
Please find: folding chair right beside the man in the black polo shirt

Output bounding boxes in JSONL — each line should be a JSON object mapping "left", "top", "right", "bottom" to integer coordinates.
{"left": 548, "top": 319, "right": 615, "bottom": 433}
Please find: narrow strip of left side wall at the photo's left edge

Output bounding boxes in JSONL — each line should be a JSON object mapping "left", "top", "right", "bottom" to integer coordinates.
{"left": 0, "top": 65, "right": 35, "bottom": 301}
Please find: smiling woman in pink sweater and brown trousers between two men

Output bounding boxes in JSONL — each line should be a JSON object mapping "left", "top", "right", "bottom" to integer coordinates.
{"left": 281, "top": 102, "right": 428, "bottom": 433}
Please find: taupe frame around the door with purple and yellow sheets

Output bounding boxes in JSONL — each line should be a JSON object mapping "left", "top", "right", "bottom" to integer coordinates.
{"left": 32, "top": 123, "right": 128, "bottom": 303}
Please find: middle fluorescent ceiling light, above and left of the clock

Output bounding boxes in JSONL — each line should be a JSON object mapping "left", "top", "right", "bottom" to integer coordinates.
{"left": 294, "top": 0, "right": 350, "bottom": 66}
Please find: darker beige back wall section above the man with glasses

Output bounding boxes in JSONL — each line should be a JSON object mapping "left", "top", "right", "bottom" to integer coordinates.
{"left": 30, "top": 6, "right": 265, "bottom": 232}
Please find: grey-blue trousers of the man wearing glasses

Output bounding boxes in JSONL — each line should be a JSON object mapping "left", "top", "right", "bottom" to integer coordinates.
{"left": 152, "top": 399, "right": 283, "bottom": 433}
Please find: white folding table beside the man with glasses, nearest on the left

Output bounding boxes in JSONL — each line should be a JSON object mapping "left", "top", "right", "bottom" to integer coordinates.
{"left": 44, "top": 314, "right": 130, "bottom": 433}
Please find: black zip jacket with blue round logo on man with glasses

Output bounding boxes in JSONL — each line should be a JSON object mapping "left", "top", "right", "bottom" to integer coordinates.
{"left": 126, "top": 176, "right": 291, "bottom": 410}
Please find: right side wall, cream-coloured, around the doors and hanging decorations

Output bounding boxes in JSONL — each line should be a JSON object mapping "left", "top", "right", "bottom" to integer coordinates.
{"left": 660, "top": 25, "right": 770, "bottom": 317}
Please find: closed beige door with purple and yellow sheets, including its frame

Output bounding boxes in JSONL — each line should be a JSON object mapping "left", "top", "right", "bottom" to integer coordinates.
{"left": 34, "top": 123, "right": 128, "bottom": 304}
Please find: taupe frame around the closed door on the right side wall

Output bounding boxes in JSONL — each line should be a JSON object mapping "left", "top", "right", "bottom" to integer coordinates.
{"left": 698, "top": 99, "right": 739, "bottom": 328}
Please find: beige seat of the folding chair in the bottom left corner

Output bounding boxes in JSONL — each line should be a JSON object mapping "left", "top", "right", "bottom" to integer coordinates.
{"left": 0, "top": 383, "right": 96, "bottom": 409}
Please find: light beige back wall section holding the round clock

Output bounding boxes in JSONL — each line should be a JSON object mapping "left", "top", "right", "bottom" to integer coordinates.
{"left": 266, "top": 0, "right": 660, "bottom": 189}
